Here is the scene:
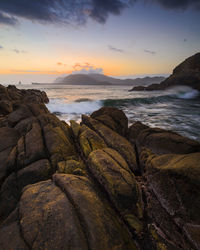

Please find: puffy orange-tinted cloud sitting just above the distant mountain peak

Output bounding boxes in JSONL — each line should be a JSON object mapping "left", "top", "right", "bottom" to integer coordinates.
{"left": 72, "top": 62, "right": 103, "bottom": 74}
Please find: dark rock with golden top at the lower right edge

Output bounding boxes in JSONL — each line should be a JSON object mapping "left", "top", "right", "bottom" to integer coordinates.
{"left": 141, "top": 149, "right": 200, "bottom": 249}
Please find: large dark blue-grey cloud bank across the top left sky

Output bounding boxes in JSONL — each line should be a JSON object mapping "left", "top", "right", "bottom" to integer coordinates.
{"left": 0, "top": 0, "right": 135, "bottom": 25}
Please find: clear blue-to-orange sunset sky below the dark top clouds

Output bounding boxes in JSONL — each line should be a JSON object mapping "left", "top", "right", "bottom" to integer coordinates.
{"left": 0, "top": 2, "right": 200, "bottom": 82}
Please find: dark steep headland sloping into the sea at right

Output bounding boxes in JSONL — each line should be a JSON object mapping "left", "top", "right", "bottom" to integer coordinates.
{"left": 131, "top": 53, "right": 200, "bottom": 91}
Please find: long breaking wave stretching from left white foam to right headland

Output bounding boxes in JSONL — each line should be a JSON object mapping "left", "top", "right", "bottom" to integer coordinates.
{"left": 47, "top": 86, "right": 199, "bottom": 116}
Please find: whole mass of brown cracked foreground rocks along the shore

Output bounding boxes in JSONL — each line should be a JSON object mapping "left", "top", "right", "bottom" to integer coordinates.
{"left": 0, "top": 85, "right": 200, "bottom": 250}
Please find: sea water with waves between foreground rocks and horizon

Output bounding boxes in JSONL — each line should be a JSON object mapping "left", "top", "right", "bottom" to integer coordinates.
{"left": 19, "top": 85, "right": 200, "bottom": 141}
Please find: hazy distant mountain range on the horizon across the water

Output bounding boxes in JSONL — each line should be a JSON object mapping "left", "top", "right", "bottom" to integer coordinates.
{"left": 54, "top": 74, "right": 165, "bottom": 86}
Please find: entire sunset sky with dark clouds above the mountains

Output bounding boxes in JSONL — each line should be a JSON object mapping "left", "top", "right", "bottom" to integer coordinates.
{"left": 0, "top": 0, "right": 200, "bottom": 84}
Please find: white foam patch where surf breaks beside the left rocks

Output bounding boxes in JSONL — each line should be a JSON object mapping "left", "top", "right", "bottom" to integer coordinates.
{"left": 47, "top": 99, "right": 102, "bottom": 114}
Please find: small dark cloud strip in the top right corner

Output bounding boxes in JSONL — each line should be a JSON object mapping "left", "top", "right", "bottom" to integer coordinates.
{"left": 153, "top": 0, "right": 200, "bottom": 10}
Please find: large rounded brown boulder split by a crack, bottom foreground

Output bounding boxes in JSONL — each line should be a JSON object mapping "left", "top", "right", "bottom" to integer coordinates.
{"left": 14, "top": 175, "right": 136, "bottom": 249}
